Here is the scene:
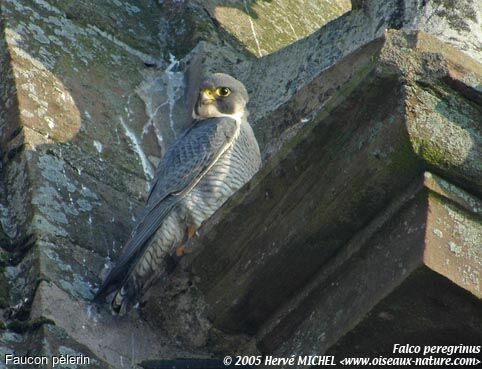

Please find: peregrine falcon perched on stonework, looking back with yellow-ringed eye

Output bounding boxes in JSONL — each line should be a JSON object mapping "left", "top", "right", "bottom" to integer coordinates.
{"left": 94, "top": 73, "right": 261, "bottom": 315}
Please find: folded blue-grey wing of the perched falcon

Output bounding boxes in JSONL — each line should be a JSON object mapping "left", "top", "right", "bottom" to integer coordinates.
{"left": 94, "top": 117, "right": 238, "bottom": 300}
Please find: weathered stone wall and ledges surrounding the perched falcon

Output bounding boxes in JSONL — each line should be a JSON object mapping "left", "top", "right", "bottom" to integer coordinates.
{"left": 0, "top": 0, "right": 482, "bottom": 368}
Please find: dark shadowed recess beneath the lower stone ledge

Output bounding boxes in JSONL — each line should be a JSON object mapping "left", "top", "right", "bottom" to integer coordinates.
{"left": 326, "top": 267, "right": 482, "bottom": 359}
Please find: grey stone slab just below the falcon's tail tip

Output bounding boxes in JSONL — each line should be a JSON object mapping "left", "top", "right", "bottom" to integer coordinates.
{"left": 30, "top": 282, "right": 203, "bottom": 368}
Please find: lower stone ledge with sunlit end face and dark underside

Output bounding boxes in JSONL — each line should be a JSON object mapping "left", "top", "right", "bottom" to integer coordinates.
{"left": 257, "top": 173, "right": 482, "bottom": 362}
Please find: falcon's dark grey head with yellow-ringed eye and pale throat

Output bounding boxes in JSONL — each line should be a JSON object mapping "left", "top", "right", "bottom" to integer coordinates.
{"left": 193, "top": 73, "right": 249, "bottom": 119}
